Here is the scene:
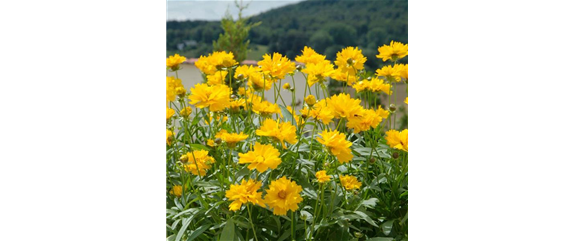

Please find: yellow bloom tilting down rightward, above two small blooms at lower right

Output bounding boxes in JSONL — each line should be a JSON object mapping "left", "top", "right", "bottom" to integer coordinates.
{"left": 317, "top": 130, "right": 353, "bottom": 164}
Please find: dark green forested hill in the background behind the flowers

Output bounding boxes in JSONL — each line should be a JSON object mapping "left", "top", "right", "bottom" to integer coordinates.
{"left": 166, "top": 0, "right": 406, "bottom": 68}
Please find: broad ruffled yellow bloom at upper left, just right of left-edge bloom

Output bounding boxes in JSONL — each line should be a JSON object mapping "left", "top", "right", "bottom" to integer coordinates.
{"left": 189, "top": 84, "right": 231, "bottom": 111}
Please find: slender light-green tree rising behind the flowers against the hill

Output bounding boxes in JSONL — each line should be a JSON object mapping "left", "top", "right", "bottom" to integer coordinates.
{"left": 213, "top": 0, "right": 261, "bottom": 63}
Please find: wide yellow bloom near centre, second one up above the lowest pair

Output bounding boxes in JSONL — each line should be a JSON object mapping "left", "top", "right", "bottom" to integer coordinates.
{"left": 255, "top": 119, "right": 297, "bottom": 148}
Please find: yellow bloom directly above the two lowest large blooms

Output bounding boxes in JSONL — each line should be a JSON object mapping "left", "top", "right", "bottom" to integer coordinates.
{"left": 239, "top": 142, "right": 281, "bottom": 173}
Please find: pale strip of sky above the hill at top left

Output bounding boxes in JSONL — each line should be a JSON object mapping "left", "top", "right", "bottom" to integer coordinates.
{"left": 165, "top": 0, "right": 303, "bottom": 20}
